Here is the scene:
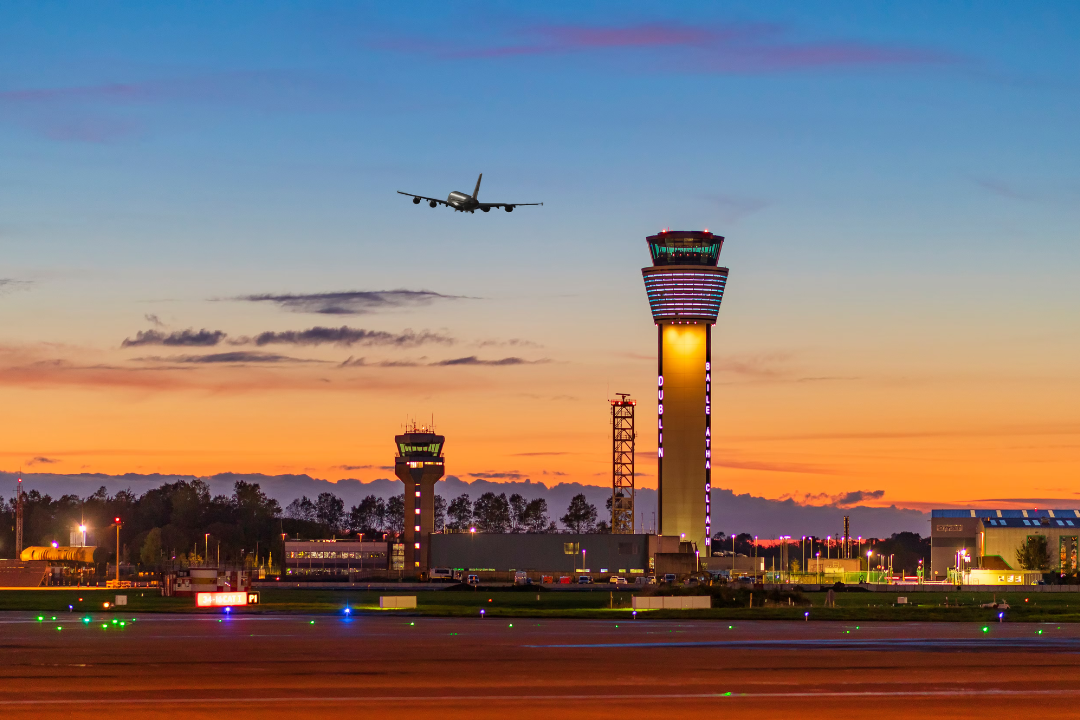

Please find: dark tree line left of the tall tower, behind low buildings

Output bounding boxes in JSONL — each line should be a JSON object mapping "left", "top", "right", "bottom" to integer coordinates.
{"left": 0, "top": 479, "right": 607, "bottom": 568}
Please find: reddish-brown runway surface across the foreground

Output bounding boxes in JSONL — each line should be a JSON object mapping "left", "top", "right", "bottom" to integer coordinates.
{"left": 0, "top": 613, "right": 1080, "bottom": 720}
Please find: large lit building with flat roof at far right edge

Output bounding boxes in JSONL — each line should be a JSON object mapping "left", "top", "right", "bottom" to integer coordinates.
{"left": 927, "top": 508, "right": 1080, "bottom": 585}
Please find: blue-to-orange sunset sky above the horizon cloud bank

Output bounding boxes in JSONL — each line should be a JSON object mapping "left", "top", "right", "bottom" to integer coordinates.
{"left": 0, "top": 2, "right": 1080, "bottom": 508}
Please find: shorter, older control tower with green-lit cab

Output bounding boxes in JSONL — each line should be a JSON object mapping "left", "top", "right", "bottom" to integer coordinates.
{"left": 394, "top": 423, "right": 446, "bottom": 575}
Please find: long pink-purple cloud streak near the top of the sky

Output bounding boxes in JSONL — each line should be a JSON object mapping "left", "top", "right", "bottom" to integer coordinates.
{"left": 378, "top": 22, "right": 959, "bottom": 74}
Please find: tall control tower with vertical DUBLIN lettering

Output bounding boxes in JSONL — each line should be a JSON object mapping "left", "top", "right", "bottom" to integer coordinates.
{"left": 642, "top": 230, "right": 728, "bottom": 557}
